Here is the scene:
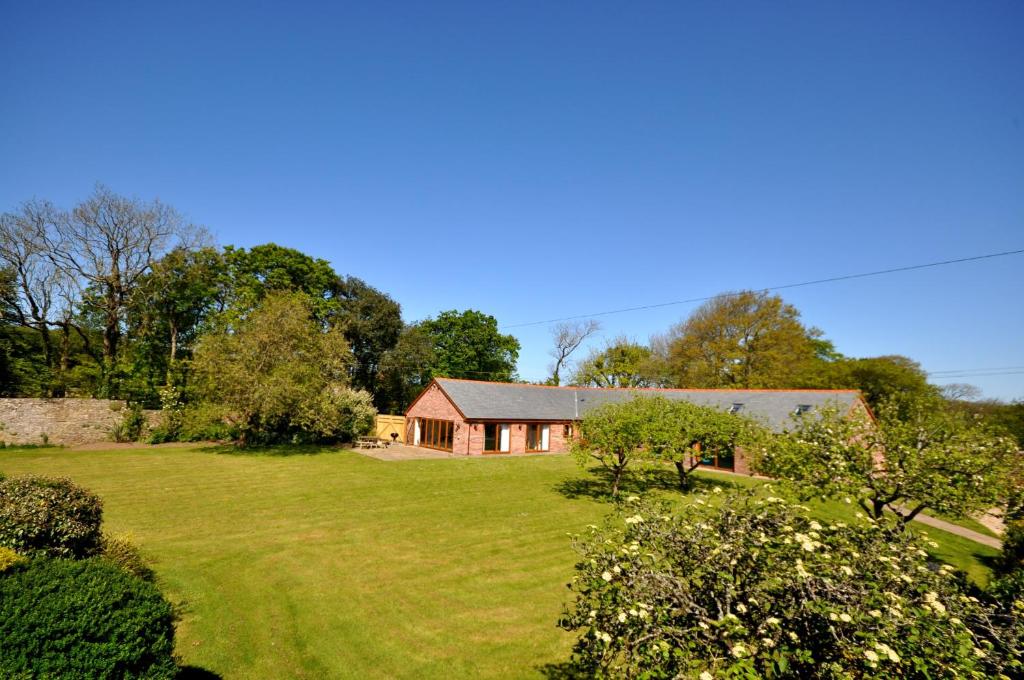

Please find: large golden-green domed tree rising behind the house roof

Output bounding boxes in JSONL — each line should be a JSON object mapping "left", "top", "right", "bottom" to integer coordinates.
{"left": 668, "top": 291, "right": 820, "bottom": 388}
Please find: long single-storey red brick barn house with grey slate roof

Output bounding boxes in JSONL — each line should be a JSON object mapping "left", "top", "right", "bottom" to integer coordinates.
{"left": 406, "top": 378, "right": 867, "bottom": 473}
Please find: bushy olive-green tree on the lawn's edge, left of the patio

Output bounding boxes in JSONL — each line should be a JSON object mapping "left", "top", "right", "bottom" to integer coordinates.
{"left": 193, "top": 293, "right": 375, "bottom": 445}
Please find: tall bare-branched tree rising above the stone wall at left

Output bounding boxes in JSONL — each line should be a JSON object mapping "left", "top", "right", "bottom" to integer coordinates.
{"left": 44, "top": 184, "right": 198, "bottom": 396}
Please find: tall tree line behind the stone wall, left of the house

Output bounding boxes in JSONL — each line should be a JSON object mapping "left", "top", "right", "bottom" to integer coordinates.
{"left": 0, "top": 185, "right": 519, "bottom": 421}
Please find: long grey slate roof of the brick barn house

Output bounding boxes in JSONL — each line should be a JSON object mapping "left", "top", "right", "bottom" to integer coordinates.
{"left": 437, "top": 378, "right": 860, "bottom": 429}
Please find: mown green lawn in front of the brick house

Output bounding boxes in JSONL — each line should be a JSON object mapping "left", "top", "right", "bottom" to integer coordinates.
{"left": 0, "top": 447, "right": 995, "bottom": 678}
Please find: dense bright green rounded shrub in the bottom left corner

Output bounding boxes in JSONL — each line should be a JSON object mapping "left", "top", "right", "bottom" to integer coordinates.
{"left": 0, "top": 559, "right": 176, "bottom": 678}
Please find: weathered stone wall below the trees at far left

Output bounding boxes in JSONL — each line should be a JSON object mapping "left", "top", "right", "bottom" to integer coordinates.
{"left": 0, "top": 398, "right": 152, "bottom": 445}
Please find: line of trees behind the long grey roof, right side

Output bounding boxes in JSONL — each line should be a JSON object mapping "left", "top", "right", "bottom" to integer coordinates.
{"left": 548, "top": 291, "right": 1024, "bottom": 444}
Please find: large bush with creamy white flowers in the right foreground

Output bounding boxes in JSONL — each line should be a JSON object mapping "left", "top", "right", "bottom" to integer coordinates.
{"left": 561, "top": 494, "right": 1021, "bottom": 680}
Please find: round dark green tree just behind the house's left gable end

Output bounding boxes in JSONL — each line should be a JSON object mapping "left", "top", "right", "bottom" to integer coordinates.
{"left": 422, "top": 309, "right": 519, "bottom": 382}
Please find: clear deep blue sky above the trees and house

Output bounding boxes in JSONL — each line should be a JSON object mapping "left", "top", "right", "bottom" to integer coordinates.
{"left": 0, "top": 1, "right": 1024, "bottom": 398}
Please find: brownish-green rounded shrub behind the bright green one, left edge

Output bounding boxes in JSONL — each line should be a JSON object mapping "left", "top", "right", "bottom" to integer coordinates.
{"left": 0, "top": 476, "right": 103, "bottom": 557}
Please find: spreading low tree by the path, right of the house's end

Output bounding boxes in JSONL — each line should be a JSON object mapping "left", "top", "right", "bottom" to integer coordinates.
{"left": 754, "top": 396, "right": 1016, "bottom": 523}
